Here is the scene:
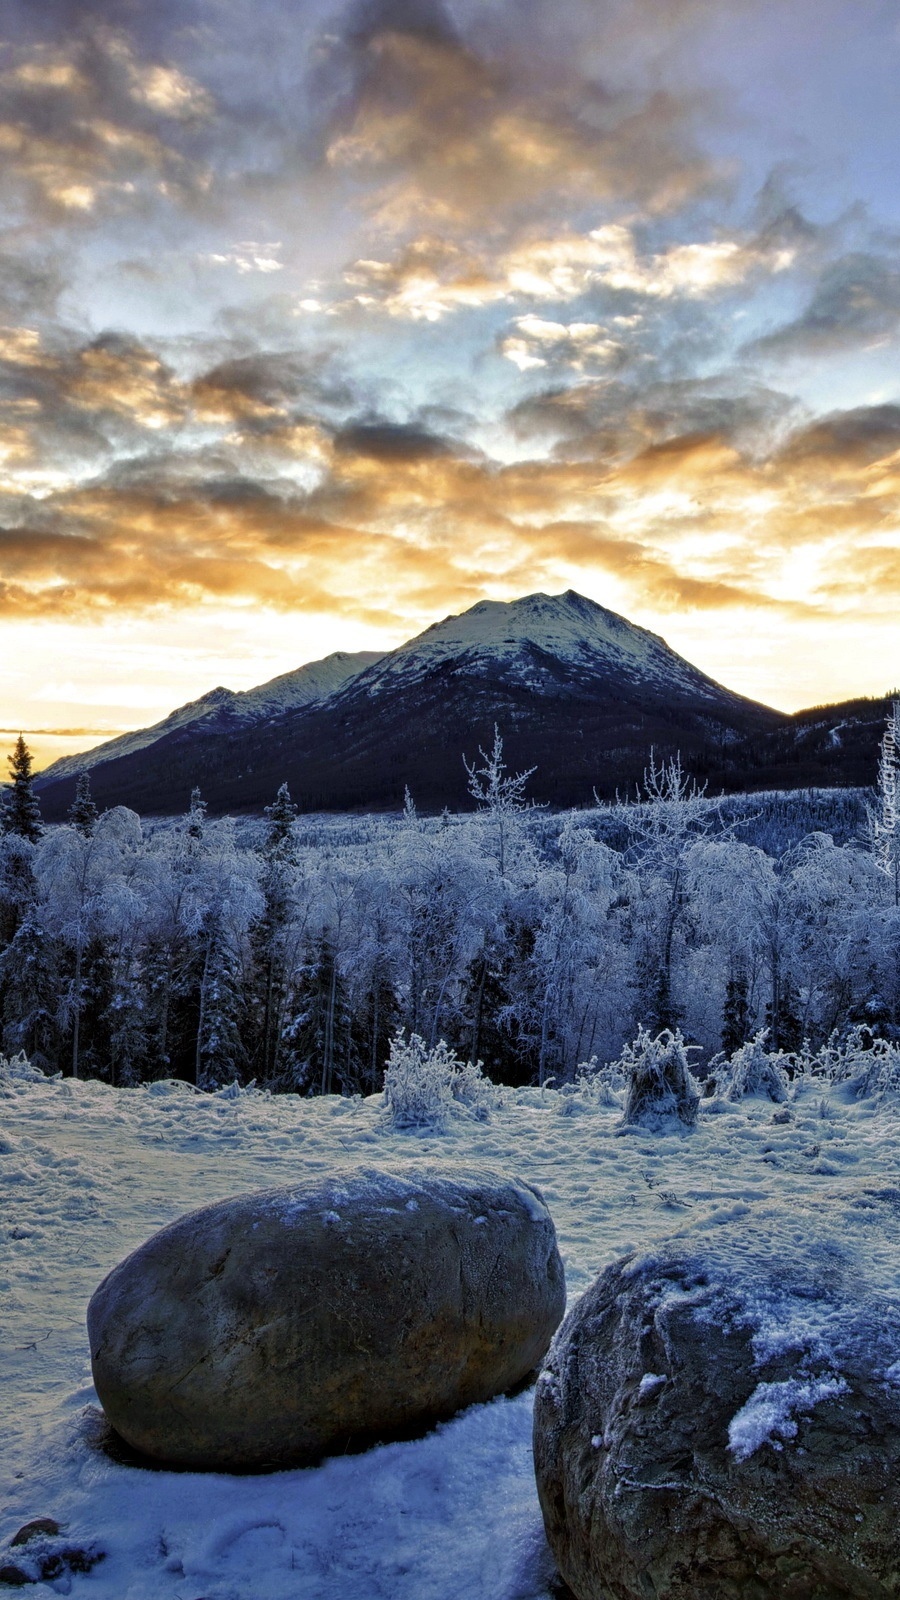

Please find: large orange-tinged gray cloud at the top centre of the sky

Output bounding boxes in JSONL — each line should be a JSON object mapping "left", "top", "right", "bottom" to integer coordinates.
{"left": 322, "top": 0, "right": 716, "bottom": 242}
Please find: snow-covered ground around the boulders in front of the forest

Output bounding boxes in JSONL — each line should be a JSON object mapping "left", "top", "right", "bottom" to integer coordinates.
{"left": 0, "top": 1082, "right": 898, "bottom": 1600}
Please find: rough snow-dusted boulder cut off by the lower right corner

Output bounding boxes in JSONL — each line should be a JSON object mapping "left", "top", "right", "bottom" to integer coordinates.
{"left": 535, "top": 1189, "right": 900, "bottom": 1600}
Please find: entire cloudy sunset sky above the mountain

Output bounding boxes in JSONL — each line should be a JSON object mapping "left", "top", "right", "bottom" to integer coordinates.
{"left": 0, "top": 0, "right": 900, "bottom": 762}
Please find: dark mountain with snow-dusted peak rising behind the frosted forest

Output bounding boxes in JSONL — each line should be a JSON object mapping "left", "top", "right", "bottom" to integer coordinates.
{"left": 38, "top": 592, "right": 884, "bottom": 819}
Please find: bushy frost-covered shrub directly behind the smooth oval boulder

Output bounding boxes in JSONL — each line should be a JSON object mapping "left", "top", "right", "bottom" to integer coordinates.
{"left": 376, "top": 1034, "right": 496, "bottom": 1128}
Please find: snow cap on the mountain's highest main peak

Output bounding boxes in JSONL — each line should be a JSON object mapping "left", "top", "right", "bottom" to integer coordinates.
{"left": 347, "top": 589, "right": 737, "bottom": 701}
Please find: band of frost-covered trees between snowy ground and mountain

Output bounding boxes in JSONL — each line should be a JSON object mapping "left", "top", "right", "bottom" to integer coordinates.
{"left": 0, "top": 716, "right": 900, "bottom": 1094}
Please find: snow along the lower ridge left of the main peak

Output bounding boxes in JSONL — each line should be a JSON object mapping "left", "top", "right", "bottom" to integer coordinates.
{"left": 40, "top": 650, "right": 381, "bottom": 784}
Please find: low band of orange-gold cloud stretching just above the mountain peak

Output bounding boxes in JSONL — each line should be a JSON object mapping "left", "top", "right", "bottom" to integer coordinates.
{"left": 0, "top": 380, "right": 900, "bottom": 619}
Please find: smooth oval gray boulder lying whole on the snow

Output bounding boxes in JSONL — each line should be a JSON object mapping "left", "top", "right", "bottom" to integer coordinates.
{"left": 88, "top": 1168, "right": 565, "bottom": 1470}
